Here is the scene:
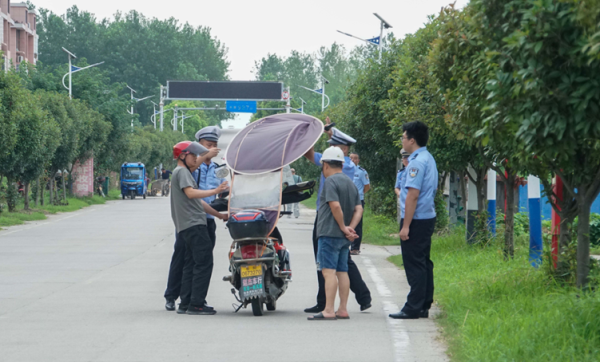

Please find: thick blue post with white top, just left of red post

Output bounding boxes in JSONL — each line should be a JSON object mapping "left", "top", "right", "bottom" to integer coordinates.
{"left": 527, "top": 175, "right": 543, "bottom": 268}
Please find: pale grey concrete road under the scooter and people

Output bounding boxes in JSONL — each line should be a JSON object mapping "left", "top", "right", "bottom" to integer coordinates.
{"left": 0, "top": 129, "right": 447, "bottom": 362}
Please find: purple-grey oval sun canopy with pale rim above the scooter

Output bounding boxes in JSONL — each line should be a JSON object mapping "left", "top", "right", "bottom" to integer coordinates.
{"left": 225, "top": 114, "right": 324, "bottom": 175}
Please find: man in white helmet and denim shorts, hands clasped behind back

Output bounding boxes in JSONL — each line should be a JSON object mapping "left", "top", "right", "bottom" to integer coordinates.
{"left": 308, "top": 146, "right": 363, "bottom": 320}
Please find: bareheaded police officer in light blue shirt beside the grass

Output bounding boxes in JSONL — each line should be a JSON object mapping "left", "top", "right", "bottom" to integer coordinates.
{"left": 390, "top": 121, "right": 438, "bottom": 319}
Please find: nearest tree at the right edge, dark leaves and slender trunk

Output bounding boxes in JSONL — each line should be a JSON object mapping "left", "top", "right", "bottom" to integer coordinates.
{"left": 482, "top": 0, "right": 600, "bottom": 287}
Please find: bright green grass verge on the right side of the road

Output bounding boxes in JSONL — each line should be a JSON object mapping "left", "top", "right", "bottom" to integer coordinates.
{"left": 391, "top": 229, "right": 600, "bottom": 362}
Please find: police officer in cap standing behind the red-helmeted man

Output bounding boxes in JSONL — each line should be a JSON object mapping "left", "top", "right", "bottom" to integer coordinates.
{"left": 165, "top": 126, "right": 226, "bottom": 313}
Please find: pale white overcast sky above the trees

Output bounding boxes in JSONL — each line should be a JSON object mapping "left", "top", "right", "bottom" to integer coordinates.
{"left": 32, "top": 0, "right": 468, "bottom": 127}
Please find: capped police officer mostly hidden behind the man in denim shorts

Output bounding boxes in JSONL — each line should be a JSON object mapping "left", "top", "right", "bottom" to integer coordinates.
{"left": 304, "top": 117, "right": 371, "bottom": 314}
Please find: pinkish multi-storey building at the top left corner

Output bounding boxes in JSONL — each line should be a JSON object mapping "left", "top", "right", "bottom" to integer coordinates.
{"left": 0, "top": 0, "right": 38, "bottom": 70}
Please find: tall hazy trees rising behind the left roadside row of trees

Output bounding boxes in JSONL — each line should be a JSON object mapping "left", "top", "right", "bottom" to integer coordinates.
{"left": 37, "top": 6, "right": 229, "bottom": 125}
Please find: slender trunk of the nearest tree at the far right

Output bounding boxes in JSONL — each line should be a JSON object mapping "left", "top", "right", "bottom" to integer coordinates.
{"left": 577, "top": 198, "right": 594, "bottom": 288}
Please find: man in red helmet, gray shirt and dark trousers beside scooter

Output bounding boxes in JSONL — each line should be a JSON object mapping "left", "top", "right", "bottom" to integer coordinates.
{"left": 171, "top": 141, "right": 227, "bottom": 315}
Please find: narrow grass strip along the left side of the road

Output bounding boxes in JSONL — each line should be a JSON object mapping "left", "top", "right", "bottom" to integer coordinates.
{"left": 0, "top": 189, "right": 121, "bottom": 227}
